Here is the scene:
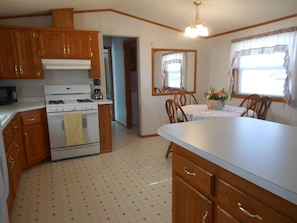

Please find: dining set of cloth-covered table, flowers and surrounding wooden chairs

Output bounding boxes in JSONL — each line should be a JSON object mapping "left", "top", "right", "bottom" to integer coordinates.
{"left": 165, "top": 89, "right": 272, "bottom": 158}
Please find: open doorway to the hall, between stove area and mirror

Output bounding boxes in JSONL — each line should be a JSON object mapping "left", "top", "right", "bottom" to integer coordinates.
{"left": 103, "top": 36, "right": 139, "bottom": 132}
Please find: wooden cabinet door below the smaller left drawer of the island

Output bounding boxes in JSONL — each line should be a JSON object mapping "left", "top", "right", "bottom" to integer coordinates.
{"left": 172, "top": 175, "right": 213, "bottom": 223}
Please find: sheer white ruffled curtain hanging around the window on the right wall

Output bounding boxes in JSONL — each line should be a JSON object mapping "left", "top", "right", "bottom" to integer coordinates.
{"left": 230, "top": 27, "right": 297, "bottom": 107}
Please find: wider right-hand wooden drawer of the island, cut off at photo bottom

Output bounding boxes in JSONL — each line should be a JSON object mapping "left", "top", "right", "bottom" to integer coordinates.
{"left": 217, "top": 179, "right": 293, "bottom": 223}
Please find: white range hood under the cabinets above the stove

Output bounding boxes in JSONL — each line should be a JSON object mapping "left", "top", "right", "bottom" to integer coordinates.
{"left": 41, "top": 59, "right": 91, "bottom": 70}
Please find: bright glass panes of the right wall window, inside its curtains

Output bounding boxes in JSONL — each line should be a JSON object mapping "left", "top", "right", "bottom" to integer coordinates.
{"left": 234, "top": 53, "right": 287, "bottom": 97}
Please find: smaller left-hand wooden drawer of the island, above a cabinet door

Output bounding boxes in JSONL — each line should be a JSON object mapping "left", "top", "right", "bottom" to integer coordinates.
{"left": 173, "top": 153, "right": 215, "bottom": 195}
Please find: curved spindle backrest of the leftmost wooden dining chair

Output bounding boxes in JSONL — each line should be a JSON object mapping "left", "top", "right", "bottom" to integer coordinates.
{"left": 165, "top": 99, "right": 188, "bottom": 123}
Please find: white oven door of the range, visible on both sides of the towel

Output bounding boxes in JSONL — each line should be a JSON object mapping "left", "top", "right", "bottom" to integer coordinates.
{"left": 47, "top": 110, "right": 99, "bottom": 149}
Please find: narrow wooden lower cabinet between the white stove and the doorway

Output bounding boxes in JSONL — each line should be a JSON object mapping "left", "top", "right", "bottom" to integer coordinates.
{"left": 98, "top": 104, "right": 112, "bottom": 153}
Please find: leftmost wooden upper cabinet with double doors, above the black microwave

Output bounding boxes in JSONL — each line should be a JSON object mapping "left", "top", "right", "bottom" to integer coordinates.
{"left": 0, "top": 28, "right": 43, "bottom": 79}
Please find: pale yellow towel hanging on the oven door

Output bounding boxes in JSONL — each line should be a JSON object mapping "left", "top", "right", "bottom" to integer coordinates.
{"left": 63, "top": 112, "right": 85, "bottom": 146}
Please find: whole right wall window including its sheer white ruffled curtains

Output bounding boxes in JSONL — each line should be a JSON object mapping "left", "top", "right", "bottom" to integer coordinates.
{"left": 229, "top": 26, "right": 297, "bottom": 107}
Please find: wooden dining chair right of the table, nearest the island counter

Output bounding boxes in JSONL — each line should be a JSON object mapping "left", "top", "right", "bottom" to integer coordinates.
{"left": 241, "top": 96, "right": 272, "bottom": 120}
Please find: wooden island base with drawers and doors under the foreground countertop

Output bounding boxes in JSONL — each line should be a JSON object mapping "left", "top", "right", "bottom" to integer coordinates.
{"left": 172, "top": 144, "right": 297, "bottom": 223}
